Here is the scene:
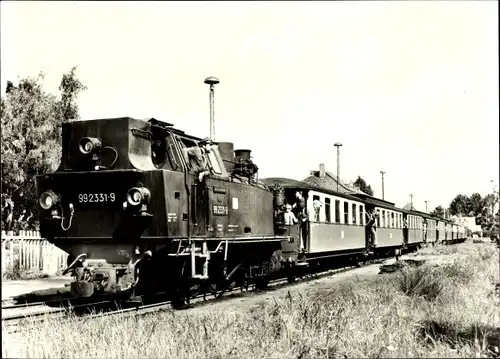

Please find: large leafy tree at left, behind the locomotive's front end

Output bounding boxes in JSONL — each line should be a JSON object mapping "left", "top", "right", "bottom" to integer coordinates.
{"left": 1, "top": 68, "right": 85, "bottom": 229}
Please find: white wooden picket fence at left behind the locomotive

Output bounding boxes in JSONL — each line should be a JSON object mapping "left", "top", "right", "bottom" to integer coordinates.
{"left": 1, "top": 231, "right": 68, "bottom": 278}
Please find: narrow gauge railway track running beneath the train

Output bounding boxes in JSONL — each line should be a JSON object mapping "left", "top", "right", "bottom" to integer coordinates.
{"left": 2, "top": 258, "right": 387, "bottom": 333}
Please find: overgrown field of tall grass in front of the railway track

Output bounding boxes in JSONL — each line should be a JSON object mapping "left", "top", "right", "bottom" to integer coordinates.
{"left": 2, "top": 244, "right": 500, "bottom": 358}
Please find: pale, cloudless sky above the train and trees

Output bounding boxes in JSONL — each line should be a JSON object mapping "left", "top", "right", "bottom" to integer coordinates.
{"left": 0, "top": 1, "right": 500, "bottom": 210}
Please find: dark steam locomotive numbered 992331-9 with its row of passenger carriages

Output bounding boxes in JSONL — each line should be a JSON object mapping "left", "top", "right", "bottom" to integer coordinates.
{"left": 35, "top": 83, "right": 467, "bottom": 307}
